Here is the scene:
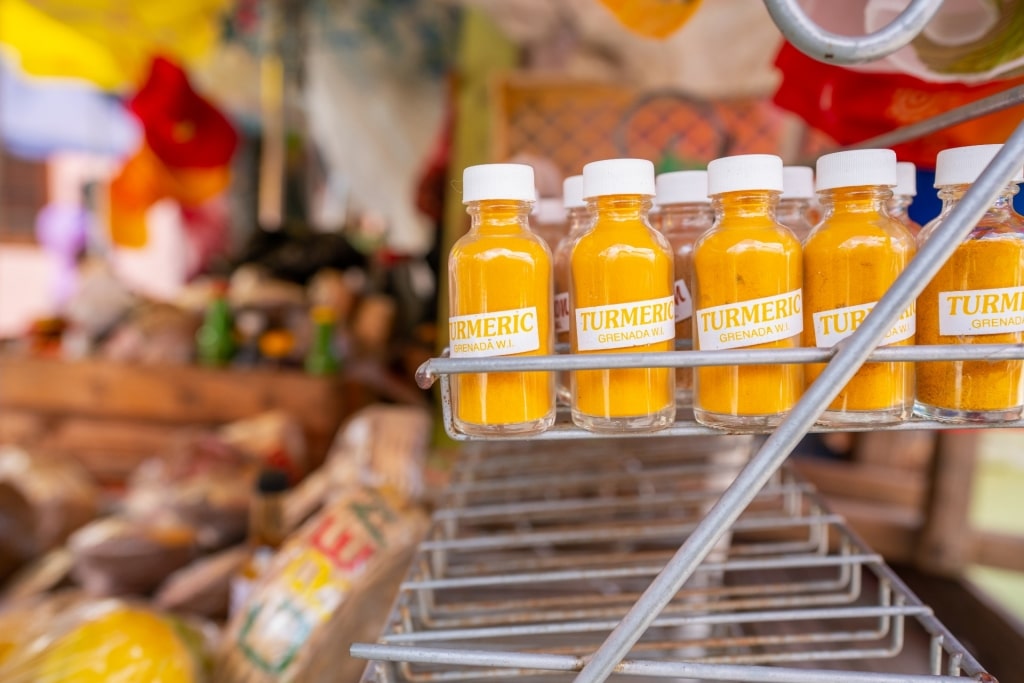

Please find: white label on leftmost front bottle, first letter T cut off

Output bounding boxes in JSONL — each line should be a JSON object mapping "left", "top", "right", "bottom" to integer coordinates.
{"left": 449, "top": 306, "right": 541, "bottom": 358}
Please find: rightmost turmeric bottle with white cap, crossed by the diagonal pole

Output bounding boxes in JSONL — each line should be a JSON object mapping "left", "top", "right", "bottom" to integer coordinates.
{"left": 914, "top": 144, "right": 1024, "bottom": 423}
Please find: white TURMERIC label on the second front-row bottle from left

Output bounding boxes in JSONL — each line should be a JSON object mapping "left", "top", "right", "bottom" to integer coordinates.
{"left": 575, "top": 296, "right": 676, "bottom": 351}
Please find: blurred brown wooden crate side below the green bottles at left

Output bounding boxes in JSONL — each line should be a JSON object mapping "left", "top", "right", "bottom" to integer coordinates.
{"left": 0, "top": 357, "right": 374, "bottom": 481}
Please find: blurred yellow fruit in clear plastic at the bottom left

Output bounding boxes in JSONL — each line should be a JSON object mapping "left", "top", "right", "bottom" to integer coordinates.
{"left": 35, "top": 607, "right": 197, "bottom": 683}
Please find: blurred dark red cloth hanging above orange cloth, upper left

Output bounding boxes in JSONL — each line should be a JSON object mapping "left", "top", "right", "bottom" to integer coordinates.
{"left": 128, "top": 56, "right": 238, "bottom": 169}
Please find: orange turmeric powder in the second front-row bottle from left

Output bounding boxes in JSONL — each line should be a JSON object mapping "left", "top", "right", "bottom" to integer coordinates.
{"left": 570, "top": 195, "right": 675, "bottom": 418}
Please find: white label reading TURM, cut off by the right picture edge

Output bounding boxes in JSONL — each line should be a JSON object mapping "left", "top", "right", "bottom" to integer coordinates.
{"left": 939, "top": 287, "right": 1024, "bottom": 337}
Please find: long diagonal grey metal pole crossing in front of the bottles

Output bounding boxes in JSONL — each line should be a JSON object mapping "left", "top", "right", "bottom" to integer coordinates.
{"left": 575, "top": 122, "right": 1024, "bottom": 683}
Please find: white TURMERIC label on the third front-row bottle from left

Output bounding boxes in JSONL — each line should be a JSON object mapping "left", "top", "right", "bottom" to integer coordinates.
{"left": 696, "top": 290, "right": 804, "bottom": 350}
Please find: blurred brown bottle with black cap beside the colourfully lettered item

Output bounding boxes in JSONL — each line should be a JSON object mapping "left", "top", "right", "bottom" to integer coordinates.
{"left": 229, "top": 469, "right": 289, "bottom": 614}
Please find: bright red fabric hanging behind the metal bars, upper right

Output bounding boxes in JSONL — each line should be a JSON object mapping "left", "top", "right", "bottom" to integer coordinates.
{"left": 773, "top": 43, "right": 1024, "bottom": 168}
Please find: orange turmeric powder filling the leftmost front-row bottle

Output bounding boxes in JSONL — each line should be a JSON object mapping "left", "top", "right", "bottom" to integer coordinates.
{"left": 449, "top": 200, "right": 554, "bottom": 430}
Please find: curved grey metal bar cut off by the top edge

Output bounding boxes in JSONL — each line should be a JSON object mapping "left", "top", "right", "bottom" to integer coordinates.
{"left": 765, "top": 0, "right": 942, "bottom": 65}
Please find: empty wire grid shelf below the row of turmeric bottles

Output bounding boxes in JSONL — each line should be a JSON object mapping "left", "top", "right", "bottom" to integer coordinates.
{"left": 352, "top": 436, "right": 990, "bottom": 683}
